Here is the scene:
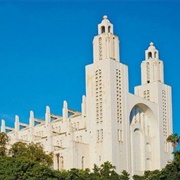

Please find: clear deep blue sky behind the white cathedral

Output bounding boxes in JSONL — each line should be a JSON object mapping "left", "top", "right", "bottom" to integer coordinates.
{"left": 0, "top": 0, "right": 180, "bottom": 135}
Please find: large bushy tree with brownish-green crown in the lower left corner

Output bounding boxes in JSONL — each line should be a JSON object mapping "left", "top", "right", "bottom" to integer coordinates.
{"left": 0, "top": 136, "right": 61, "bottom": 180}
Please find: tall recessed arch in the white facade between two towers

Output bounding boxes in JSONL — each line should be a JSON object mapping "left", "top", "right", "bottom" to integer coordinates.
{"left": 130, "top": 103, "right": 157, "bottom": 175}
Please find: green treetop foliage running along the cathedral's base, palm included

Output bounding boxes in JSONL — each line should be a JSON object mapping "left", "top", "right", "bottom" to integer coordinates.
{"left": 0, "top": 133, "right": 180, "bottom": 180}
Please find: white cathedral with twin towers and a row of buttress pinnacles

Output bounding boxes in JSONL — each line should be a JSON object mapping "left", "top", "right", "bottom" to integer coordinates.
{"left": 1, "top": 16, "right": 172, "bottom": 175}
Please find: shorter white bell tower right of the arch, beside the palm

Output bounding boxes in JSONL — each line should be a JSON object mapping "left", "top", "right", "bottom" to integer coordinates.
{"left": 135, "top": 42, "right": 172, "bottom": 170}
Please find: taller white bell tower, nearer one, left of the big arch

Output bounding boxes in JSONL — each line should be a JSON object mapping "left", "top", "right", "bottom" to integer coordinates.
{"left": 86, "top": 16, "right": 130, "bottom": 173}
